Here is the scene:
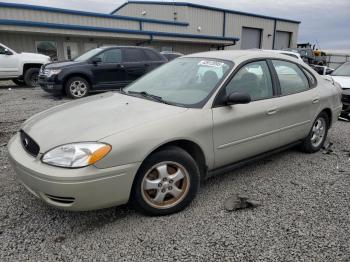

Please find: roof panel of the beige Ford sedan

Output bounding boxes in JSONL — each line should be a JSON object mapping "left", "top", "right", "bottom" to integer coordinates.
{"left": 183, "top": 50, "right": 300, "bottom": 63}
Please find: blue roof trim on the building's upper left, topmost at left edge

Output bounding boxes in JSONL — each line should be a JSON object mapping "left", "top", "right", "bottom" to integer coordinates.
{"left": 0, "top": 2, "right": 189, "bottom": 26}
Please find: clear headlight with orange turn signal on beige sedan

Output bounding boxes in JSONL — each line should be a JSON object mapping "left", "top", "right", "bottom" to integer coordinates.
{"left": 41, "top": 142, "right": 112, "bottom": 168}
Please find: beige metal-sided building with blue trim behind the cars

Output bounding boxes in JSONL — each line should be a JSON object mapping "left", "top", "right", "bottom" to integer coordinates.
{"left": 0, "top": 1, "right": 300, "bottom": 60}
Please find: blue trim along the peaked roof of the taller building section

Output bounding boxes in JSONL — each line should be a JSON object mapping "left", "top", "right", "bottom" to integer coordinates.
{"left": 112, "top": 0, "right": 301, "bottom": 24}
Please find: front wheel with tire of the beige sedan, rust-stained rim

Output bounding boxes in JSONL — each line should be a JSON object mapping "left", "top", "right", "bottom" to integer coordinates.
{"left": 131, "top": 147, "right": 200, "bottom": 216}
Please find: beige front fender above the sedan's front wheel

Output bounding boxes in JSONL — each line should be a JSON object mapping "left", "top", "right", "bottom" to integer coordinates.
{"left": 96, "top": 109, "right": 214, "bottom": 168}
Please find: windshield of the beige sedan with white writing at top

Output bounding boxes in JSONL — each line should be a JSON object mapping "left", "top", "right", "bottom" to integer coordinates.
{"left": 124, "top": 57, "right": 232, "bottom": 107}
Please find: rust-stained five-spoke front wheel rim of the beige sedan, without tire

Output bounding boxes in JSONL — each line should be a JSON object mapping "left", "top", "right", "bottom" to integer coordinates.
{"left": 141, "top": 161, "right": 190, "bottom": 209}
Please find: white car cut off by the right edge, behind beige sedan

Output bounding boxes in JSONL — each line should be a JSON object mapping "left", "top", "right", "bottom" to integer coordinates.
{"left": 331, "top": 62, "right": 350, "bottom": 119}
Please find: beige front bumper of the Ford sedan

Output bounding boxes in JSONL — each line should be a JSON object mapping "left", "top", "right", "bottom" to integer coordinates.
{"left": 8, "top": 134, "right": 140, "bottom": 211}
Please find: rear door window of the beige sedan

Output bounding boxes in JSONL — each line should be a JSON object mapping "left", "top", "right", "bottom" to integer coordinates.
{"left": 272, "top": 60, "right": 310, "bottom": 95}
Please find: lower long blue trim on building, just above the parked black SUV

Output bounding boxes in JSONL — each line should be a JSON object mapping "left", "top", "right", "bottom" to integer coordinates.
{"left": 0, "top": 19, "right": 239, "bottom": 41}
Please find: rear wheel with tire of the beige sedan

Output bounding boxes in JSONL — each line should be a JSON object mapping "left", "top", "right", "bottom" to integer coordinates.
{"left": 301, "top": 112, "right": 329, "bottom": 153}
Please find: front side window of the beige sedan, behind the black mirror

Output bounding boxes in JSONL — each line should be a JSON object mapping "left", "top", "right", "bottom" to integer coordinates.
{"left": 226, "top": 61, "right": 273, "bottom": 101}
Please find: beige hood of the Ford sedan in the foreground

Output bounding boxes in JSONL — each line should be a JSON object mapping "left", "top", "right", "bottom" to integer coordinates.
{"left": 22, "top": 93, "right": 187, "bottom": 153}
